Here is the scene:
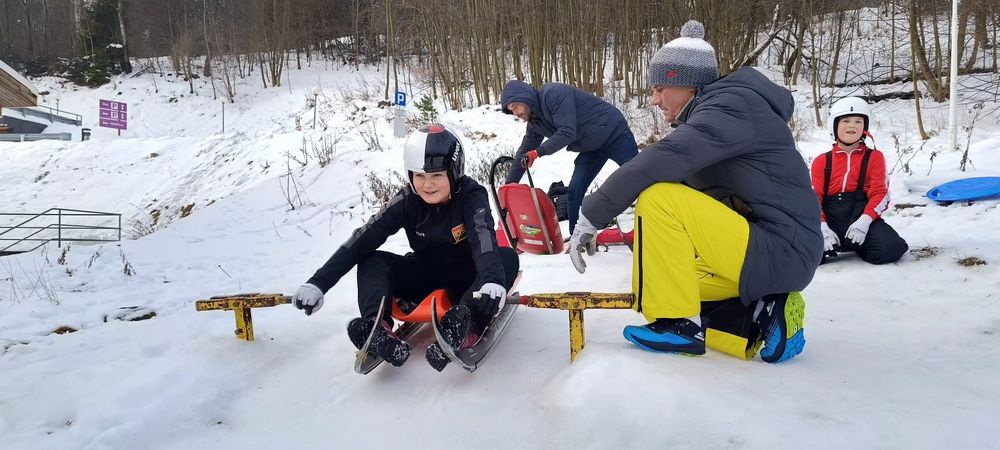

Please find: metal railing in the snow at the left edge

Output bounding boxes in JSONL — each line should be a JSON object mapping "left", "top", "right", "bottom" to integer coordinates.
{"left": 0, "top": 208, "right": 122, "bottom": 255}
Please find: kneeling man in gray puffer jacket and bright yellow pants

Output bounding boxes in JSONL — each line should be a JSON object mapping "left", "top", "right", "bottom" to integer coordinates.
{"left": 570, "top": 21, "right": 823, "bottom": 362}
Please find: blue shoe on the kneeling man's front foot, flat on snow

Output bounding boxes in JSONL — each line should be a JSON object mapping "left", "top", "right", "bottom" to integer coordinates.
{"left": 622, "top": 319, "right": 705, "bottom": 355}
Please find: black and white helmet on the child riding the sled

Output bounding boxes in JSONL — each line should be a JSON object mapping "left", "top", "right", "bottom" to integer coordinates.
{"left": 403, "top": 123, "right": 465, "bottom": 193}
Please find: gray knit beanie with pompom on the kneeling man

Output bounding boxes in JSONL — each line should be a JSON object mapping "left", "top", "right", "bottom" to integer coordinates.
{"left": 649, "top": 20, "right": 719, "bottom": 88}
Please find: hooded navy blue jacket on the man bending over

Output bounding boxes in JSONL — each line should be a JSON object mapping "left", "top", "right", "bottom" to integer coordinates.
{"left": 500, "top": 80, "right": 628, "bottom": 183}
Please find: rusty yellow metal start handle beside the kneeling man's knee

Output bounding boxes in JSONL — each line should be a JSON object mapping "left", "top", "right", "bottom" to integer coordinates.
{"left": 521, "top": 292, "right": 635, "bottom": 362}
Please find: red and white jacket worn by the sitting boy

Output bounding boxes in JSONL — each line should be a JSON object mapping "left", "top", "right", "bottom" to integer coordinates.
{"left": 812, "top": 142, "right": 889, "bottom": 222}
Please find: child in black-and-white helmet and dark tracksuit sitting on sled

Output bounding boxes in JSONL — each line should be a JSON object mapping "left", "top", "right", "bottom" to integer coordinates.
{"left": 293, "top": 124, "right": 518, "bottom": 366}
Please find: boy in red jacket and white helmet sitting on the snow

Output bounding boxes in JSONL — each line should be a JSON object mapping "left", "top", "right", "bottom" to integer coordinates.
{"left": 812, "top": 97, "right": 909, "bottom": 264}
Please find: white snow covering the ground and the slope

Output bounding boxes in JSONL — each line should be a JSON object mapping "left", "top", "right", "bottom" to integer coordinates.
{"left": 0, "top": 51, "right": 1000, "bottom": 450}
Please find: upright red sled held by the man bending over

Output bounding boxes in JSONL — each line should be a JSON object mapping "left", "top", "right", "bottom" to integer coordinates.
{"left": 490, "top": 156, "right": 563, "bottom": 255}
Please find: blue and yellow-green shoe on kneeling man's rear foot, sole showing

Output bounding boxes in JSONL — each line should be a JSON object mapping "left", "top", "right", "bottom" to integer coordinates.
{"left": 757, "top": 292, "right": 806, "bottom": 363}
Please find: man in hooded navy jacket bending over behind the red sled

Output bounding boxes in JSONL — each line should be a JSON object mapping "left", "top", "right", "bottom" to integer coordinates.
{"left": 500, "top": 80, "right": 639, "bottom": 232}
